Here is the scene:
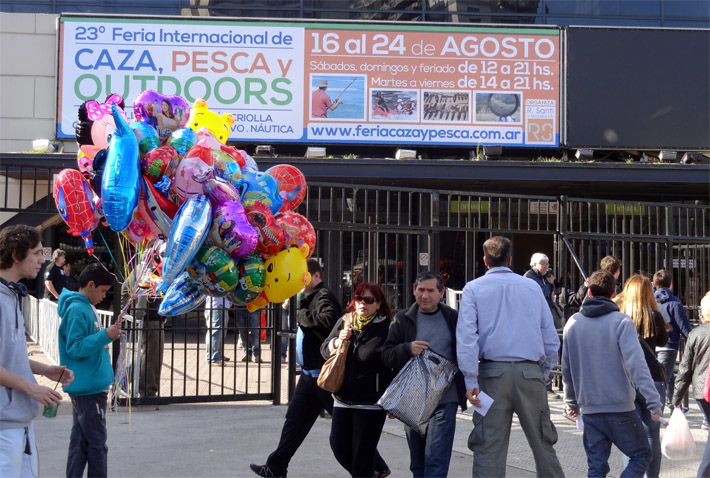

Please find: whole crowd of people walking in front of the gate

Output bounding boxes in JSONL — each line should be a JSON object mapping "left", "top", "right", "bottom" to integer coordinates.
{"left": 0, "top": 226, "right": 710, "bottom": 477}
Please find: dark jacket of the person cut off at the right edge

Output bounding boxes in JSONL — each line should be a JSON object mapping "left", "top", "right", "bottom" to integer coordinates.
{"left": 671, "top": 323, "right": 710, "bottom": 405}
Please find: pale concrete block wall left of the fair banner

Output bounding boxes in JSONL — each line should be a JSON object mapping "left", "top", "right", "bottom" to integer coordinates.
{"left": 0, "top": 13, "right": 58, "bottom": 152}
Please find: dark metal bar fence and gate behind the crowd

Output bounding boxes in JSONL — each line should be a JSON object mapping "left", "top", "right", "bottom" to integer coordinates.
{"left": 0, "top": 158, "right": 710, "bottom": 403}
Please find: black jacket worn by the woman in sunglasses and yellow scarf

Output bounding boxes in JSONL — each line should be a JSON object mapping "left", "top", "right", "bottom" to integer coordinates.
{"left": 321, "top": 316, "right": 395, "bottom": 405}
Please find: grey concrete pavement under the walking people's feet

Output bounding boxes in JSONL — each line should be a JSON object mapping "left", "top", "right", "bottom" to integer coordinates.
{"left": 32, "top": 347, "right": 707, "bottom": 478}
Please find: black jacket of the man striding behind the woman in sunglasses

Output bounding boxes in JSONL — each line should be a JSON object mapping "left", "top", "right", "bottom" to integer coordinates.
{"left": 296, "top": 282, "right": 343, "bottom": 370}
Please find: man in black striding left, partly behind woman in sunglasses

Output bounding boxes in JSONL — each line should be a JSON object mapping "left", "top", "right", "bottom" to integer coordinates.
{"left": 249, "top": 259, "right": 389, "bottom": 477}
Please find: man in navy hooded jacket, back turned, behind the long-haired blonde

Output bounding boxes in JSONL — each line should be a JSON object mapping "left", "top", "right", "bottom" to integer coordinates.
{"left": 653, "top": 269, "right": 691, "bottom": 408}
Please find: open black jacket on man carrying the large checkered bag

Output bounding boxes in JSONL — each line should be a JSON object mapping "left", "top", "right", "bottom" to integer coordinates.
{"left": 382, "top": 303, "right": 467, "bottom": 410}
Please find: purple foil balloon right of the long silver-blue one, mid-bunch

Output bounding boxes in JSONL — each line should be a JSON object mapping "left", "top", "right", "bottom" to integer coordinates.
{"left": 206, "top": 201, "right": 259, "bottom": 260}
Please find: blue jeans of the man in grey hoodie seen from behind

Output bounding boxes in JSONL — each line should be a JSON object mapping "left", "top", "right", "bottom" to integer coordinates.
{"left": 582, "top": 410, "right": 651, "bottom": 478}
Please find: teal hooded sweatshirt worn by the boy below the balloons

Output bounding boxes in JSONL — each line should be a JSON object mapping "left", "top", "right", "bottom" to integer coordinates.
{"left": 57, "top": 289, "right": 113, "bottom": 397}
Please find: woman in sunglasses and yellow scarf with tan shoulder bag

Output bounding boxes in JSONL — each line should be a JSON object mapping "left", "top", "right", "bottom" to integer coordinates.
{"left": 321, "top": 282, "right": 394, "bottom": 477}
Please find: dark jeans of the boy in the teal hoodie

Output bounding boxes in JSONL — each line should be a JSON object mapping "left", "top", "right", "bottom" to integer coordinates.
{"left": 67, "top": 392, "right": 108, "bottom": 478}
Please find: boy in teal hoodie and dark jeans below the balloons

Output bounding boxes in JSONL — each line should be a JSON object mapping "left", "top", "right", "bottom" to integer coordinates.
{"left": 57, "top": 264, "right": 123, "bottom": 477}
